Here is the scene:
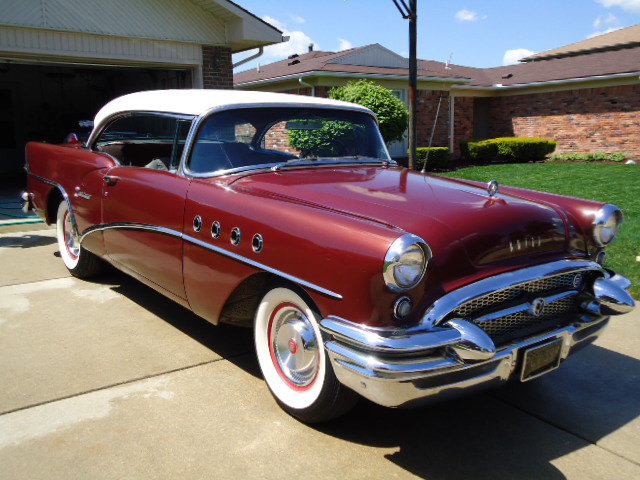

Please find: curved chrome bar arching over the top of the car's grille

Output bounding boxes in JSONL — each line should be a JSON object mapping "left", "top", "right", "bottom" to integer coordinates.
{"left": 421, "top": 260, "right": 603, "bottom": 327}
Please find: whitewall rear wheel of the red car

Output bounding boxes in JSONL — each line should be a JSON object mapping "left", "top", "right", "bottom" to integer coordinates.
{"left": 56, "top": 202, "right": 104, "bottom": 278}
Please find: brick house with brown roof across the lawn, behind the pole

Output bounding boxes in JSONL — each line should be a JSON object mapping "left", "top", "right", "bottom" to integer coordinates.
{"left": 234, "top": 25, "right": 640, "bottom": 157}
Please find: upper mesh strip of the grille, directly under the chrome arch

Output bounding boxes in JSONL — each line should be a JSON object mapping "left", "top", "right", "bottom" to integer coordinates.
{"left": 453, "top": 272, "right": 582, "bottom": 318}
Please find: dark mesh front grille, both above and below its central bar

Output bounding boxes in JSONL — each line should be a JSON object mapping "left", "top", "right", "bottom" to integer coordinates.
{"left": 451, "top": 272, "right": 585, "bottom": 345}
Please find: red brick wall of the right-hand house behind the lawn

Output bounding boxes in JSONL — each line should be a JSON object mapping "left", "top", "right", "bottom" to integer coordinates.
{"left": 490, "top": 85, "right": 640, "bottom": 156}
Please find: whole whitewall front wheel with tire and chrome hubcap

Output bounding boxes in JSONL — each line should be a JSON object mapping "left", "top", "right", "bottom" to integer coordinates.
{"left": 254, "top": 287, "right": 358, "bottom": 423}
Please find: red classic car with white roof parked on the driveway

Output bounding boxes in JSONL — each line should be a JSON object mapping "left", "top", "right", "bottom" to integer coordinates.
{"left": 23, "top": 90, "right": 634, "bottom": 422}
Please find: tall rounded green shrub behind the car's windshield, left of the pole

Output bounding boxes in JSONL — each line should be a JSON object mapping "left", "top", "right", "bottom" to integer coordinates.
{"left": 329, "top": 80, "right": 409, "bottom": 143}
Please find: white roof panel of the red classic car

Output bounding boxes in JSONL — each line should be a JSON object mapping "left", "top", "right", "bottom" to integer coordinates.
{"left": 94, "top": 89, "right": 372, "bottom": 127}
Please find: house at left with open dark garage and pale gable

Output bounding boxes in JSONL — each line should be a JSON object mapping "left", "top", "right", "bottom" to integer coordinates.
{"left": 0, "top": 0, "right": 285, "bottom": 178}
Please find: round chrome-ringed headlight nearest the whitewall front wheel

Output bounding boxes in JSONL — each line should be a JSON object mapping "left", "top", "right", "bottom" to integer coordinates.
{"left": 382, "top": 233, "right": 431, "bottom": 292}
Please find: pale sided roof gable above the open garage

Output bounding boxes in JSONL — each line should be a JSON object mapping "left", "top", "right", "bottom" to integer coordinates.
{"left": 0, "top": 0, "right": 282, "bottom": 50}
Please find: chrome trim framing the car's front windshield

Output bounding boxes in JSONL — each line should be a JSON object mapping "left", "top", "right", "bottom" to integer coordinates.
{"left": 178, "top": 102, "right": 397, "bottom": 178}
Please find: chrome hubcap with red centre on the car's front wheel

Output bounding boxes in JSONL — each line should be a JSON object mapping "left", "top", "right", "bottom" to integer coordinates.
{"left": 271, "top": 305, "right": 319, "bottom": 387}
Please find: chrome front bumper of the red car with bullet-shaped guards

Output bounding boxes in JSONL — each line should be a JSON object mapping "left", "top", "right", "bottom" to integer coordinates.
{"left": 320, "top": 261, "right": 634, "bottom": 407}
